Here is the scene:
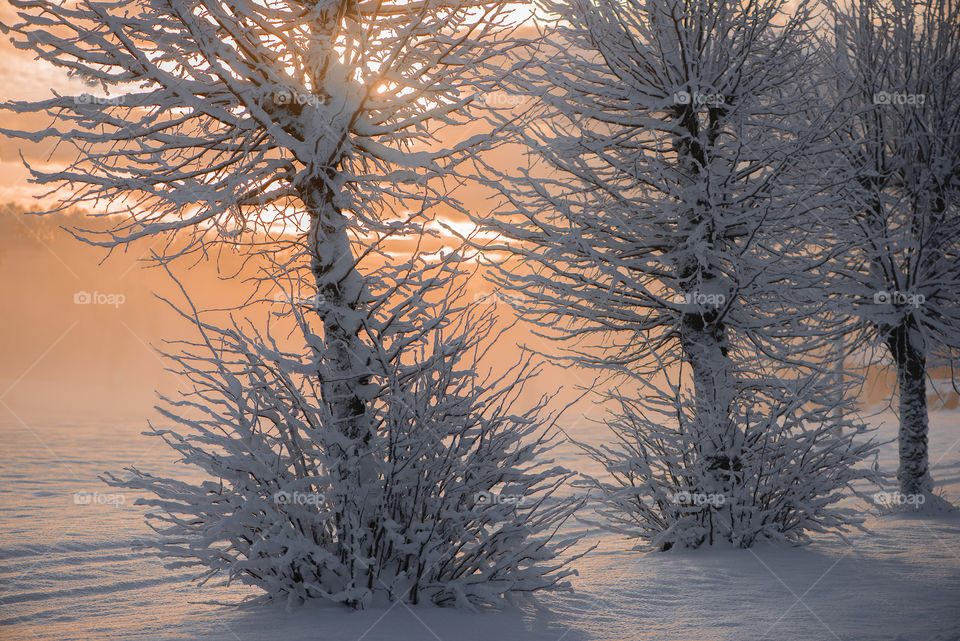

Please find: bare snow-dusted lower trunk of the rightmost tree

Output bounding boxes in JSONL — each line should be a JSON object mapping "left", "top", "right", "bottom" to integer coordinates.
{"left": 887, "top": 323, "right": 933, "bottom": 495}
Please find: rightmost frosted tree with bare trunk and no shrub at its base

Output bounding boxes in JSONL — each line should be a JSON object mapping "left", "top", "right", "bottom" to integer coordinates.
{"left": 831, "top": 0, "right": 960, "bottom": 510}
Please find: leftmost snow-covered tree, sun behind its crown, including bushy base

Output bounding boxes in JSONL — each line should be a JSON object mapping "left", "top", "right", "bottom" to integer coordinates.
{"left": 3, "top": 0, "right": 584, "bottom": 607}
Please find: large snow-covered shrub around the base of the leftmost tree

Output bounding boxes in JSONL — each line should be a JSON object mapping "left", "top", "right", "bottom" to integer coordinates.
{"left": 106, "top": 261, "right": 579, "bottom": 608}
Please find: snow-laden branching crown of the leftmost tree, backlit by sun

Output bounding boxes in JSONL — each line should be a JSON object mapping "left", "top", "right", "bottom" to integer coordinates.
{"left": 0, "top": 0, "right": 519, "bottom": 255}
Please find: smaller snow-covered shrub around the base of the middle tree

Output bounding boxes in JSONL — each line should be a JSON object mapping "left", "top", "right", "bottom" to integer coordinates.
{"left": 580, "top": 376, "right": 876, "bottom": 550}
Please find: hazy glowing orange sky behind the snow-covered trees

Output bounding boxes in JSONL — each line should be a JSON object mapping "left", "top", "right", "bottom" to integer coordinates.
{"left": 0, "top": 0, "right": 586, "bottom": 430}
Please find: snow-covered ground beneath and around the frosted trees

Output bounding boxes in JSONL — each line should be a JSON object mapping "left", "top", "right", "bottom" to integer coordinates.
{"left": 0, "top": 412, "right": 960, "bottom": 641}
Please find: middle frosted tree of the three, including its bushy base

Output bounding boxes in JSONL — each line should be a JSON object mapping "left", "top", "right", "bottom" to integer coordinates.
{"left": 472, "top": 0, "right": 866, "bottom": 547}
